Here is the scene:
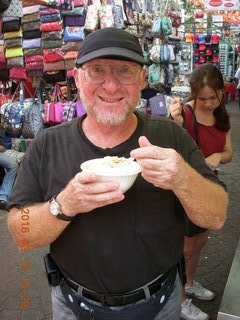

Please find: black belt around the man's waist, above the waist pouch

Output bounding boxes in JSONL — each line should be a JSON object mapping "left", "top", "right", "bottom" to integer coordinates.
{"left": 64, "top": 267, "right": 177, "bottom": 307}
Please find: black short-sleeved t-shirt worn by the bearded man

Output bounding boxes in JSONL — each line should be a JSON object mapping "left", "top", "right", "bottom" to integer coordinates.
{"left": 8, "top": 113, "right": 225, "bottom": 293}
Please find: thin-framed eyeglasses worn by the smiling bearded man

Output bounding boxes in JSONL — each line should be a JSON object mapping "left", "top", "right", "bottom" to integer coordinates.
{"left": 81, "top": 65, "right": 141, "bottom": 84}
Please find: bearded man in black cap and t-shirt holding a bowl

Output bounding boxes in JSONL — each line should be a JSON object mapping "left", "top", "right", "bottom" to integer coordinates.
{"left": 8, "top": 28, "right": 228, "bottom": 320}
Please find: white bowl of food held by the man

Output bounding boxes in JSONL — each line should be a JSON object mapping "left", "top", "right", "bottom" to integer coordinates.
{"left": 80, "top": 158, "right": 141, "bottom": 193}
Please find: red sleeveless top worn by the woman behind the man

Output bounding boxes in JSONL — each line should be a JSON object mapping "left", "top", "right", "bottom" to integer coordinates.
{"left": 184, "top": 108, "right": 226, "bottom": 158}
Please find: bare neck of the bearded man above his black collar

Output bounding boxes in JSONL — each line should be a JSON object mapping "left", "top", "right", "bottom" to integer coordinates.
{"left": 82, "top": 114, "right": 137, "bottom": 149}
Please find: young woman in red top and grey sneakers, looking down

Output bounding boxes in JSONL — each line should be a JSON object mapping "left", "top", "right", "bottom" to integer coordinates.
{"left": 170, "top": 64, "right": 232, "bottom": 320}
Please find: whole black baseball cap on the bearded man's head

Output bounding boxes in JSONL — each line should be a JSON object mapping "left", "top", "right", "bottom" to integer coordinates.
{"left": 76, "top": 28, "right": 147, "bottom": 68}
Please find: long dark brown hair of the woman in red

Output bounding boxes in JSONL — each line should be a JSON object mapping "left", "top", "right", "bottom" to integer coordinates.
{"left": 190, "top": 63, "right": 230, "bottom": 132}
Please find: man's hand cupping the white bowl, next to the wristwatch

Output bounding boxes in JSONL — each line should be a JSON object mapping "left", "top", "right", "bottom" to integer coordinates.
{"left": 57, "top": 171, "right": 124, "bottom": 216}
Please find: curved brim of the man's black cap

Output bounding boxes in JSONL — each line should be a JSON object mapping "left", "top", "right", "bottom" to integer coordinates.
{"left": 76, "top": 47, "right": 147, "bottom": 67}
